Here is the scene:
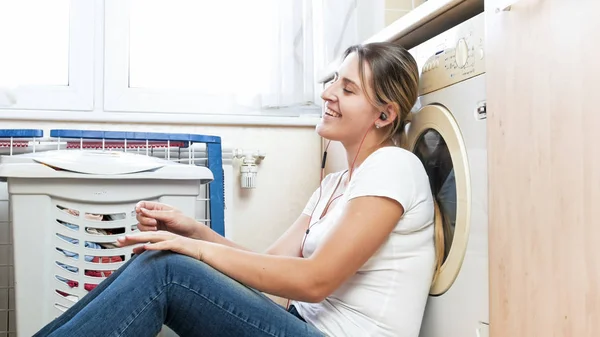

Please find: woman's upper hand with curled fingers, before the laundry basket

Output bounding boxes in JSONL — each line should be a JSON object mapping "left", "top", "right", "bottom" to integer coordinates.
{"left": 135, "top": 201, "right": 202, "bottom": 237}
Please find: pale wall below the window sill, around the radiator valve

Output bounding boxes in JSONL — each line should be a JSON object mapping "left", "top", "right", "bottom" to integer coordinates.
{"left": 0, "top": 120, "right": 321, "bottom": 250}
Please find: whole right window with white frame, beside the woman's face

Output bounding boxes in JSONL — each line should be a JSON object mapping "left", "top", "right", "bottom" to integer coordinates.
{"left": 105, "top": 0, "right": 328, "bottom": 115}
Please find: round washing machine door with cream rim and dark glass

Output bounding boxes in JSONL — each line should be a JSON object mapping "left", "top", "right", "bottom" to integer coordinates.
{"left": 405, "top": 104, "right": 471, "bottom": 296}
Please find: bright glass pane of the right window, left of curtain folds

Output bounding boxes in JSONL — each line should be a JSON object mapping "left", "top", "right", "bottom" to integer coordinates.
{"left": 128, "top": 0, "right": 278, "bottom": 95}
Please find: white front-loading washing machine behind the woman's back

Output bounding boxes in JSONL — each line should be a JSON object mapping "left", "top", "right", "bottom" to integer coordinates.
{"left": 404, "top": 14, "right": 489, "bottom": 337}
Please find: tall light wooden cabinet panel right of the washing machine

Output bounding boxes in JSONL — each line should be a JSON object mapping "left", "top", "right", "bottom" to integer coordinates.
{"left": 485, "top": 0, "right": 600, "bottom": 337}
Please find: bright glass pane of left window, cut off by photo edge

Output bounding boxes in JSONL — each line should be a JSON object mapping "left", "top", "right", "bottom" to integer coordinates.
{"left": 0, "top": 0, "right": 94, "bottom": 113}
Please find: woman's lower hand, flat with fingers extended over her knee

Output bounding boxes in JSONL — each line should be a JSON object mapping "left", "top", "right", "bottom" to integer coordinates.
{"left": 117, "top": 231, "right": 205, "bottom": 261}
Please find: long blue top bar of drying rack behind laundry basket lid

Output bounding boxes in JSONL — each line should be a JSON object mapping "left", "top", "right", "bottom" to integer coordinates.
{"left": 50, "top": 130, "right": 221, "bottom": 144}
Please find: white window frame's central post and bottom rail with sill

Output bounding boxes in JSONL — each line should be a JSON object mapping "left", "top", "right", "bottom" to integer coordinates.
{"left": 0, "top": 0, "right": 322, "bottom": 127}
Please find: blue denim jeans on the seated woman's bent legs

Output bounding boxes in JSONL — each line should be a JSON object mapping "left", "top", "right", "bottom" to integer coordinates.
{"left": 34, "top": 251, "right": 324, "bottom": 337}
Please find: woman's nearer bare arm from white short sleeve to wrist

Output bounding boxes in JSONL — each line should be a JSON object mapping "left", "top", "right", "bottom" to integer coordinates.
{"left": 199, "top": 196, "right": 404, "bottom": 302}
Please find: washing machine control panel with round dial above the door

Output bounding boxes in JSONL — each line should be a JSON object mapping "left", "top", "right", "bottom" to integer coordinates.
{"left": 419, "top": 15, "right": 485, "bottom": 95}
